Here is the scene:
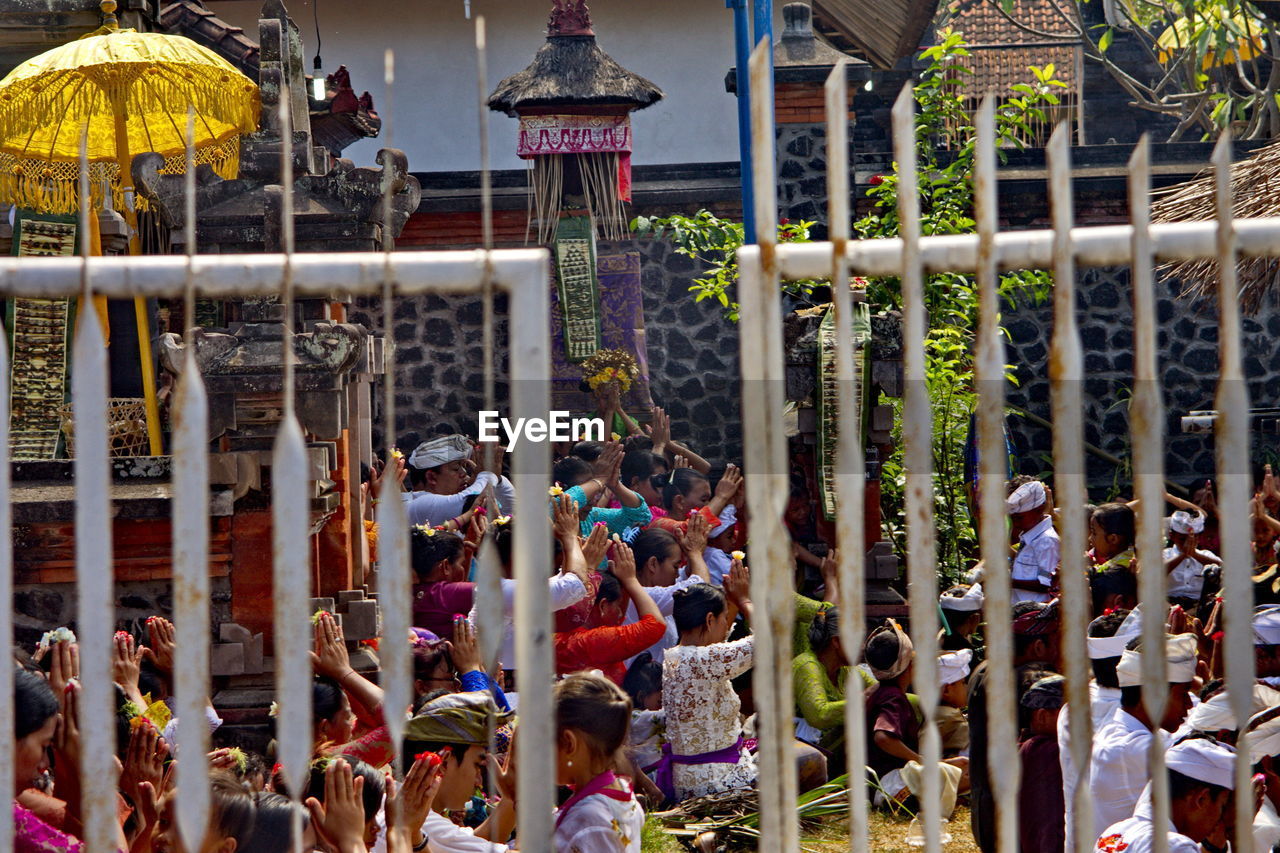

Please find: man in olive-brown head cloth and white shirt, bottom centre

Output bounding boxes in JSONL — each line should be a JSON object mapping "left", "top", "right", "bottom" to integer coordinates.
{"left": 401, "top": 693, "right": 516, "bottom": 853}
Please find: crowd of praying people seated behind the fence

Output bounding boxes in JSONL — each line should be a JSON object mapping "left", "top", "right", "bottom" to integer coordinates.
{"left": 13, "top": 394, "right": 1280, "bottom": 853}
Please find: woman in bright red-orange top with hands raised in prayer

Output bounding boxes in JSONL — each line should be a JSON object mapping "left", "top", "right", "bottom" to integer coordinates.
{"left": 553, "top": 540, "right": 667, "bottom": 684}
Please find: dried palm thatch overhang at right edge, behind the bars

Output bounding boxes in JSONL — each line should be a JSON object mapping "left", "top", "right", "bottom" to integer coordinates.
{"left": 1151, "top": 142, "right": 1280, "bottom": 314}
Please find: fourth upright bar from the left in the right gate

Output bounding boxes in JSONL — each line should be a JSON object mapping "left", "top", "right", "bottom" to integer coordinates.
{"left": 973, "top": 96, "right": 1020, "bottom": 853}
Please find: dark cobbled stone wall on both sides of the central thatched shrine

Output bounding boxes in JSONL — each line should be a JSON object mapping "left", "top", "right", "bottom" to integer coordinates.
{"left": 351, "top": 240, "right": 742, "bottom": 464}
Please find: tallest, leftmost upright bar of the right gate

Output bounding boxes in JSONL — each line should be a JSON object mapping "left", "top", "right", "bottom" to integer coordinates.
{"left": 741, "top": 34, "right": 800, "bottom": 853}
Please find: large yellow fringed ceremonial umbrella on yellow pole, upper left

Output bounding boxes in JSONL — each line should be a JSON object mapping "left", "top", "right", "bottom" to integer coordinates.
{"left": 0, "top": 0, "right": 261, "bottom": 455}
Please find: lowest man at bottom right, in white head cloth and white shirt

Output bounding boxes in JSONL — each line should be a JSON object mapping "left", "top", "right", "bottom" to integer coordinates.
{"left": 1093, "top": 738, "right": 1235, "bottom": 853}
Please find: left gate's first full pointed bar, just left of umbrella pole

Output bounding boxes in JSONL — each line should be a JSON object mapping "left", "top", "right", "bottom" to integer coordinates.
{"left": 74, "top": 142, "right": 116, "bottom": 853}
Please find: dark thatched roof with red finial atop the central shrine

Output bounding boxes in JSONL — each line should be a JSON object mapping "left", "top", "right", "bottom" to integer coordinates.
{"left": 489, "top": 0, "right": 663, "bottom": 115}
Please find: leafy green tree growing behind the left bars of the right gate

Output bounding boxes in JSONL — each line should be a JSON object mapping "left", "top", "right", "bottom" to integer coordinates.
{"left": 631, "top": 33, "right": 1064, "bottom": 579}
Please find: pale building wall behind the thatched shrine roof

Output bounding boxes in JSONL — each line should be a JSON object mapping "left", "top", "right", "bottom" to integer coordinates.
{"left": 209, "top": 0, "right": 757, "bottom": 172}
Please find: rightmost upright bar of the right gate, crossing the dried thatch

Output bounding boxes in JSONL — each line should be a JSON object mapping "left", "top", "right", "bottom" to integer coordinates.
{"left": 1213, "top": 131, "right": 1253, "bottom": 853}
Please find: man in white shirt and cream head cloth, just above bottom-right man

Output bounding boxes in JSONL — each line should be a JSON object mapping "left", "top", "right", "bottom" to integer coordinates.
{"left": 1089, "top": 634, "right": 1197, "bottom": 835}
